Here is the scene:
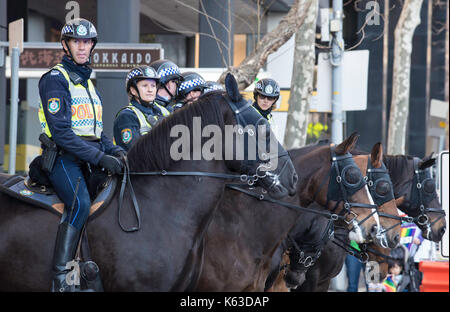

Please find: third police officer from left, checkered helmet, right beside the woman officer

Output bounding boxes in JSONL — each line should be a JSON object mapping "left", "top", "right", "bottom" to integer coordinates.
{"left": 150, "top": 60, "right": 183, "bottom": 112}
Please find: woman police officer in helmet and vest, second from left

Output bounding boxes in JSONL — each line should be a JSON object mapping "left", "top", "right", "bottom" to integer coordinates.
{"left": 114, "top": 65, "right": 170, "bottom": 151}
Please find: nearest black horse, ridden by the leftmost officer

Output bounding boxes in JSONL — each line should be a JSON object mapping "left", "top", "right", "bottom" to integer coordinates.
{"left": 0, "top": 73, "right": 296, "bottom": 291}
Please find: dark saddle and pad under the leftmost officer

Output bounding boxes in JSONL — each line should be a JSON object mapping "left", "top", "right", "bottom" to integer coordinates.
{"left": 0, "top": 175, "right": 117, "bottom": 218}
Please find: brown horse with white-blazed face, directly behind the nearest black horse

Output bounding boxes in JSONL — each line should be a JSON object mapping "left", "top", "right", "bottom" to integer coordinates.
{"left": 196, "top": 134, "right": 378, "bottom": 291}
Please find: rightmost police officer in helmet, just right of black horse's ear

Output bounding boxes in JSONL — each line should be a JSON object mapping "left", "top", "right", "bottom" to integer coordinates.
{"left": 253, "top": 78, "right": 280, "bottom": 123}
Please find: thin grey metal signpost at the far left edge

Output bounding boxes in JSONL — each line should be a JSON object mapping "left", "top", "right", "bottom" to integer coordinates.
{"left": 8, "top": 48, "right": 20, "bottom": 174}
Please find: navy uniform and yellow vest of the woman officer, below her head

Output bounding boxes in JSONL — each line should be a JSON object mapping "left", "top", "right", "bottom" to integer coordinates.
{"left": 114, "top": 98, "right": 170, "bottom": 151}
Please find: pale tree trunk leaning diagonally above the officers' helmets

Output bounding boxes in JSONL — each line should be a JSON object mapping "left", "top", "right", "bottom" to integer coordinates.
{"left": 219, "top": 0, "right": 317, "bottom": 90}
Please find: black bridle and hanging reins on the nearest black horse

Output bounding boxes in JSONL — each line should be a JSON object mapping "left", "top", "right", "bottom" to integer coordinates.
{"left": 118, "top": 96, "right": 288, "bottom": 232}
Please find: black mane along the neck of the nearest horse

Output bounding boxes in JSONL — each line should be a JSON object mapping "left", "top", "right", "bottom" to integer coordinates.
{"left": 127, "top": 92, "right": 225, "bottom": 172}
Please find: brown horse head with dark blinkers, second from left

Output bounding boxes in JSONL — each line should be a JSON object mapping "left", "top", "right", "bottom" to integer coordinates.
{"left": 296, "top": 133, "right": 378, "bottom": 243}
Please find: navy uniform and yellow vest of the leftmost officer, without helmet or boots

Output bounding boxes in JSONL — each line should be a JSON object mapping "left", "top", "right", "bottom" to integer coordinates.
{"left": 39, "top": 56, "right": 123, "bottom": 230}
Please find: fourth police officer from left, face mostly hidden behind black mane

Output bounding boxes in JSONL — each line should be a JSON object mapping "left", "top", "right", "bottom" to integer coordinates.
{"left": 171, "top": 72, "right": 206, "bottom": 111}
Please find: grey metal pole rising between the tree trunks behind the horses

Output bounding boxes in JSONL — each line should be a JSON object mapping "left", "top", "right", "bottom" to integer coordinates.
{"left": 330, "top": 0, "right": 344, "bottom": 144}
